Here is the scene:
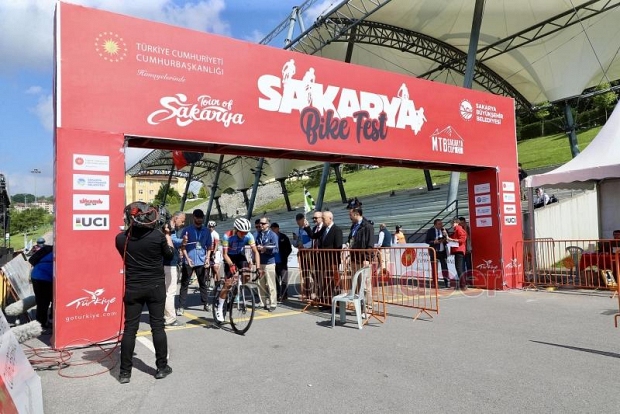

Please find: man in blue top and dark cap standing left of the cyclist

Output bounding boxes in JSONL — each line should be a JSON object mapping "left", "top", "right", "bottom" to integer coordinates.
{"left": 177, "top": 209, "right": 213, "bottom": 315}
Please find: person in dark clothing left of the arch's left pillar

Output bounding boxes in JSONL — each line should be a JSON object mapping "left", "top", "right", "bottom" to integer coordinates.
{"left": 28, "top": 241, "right": 54, "bottom": 333}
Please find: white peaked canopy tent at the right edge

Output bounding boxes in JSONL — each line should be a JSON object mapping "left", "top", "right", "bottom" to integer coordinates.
{"left": 525, "top": 105, "right": 620, "bottom": 238}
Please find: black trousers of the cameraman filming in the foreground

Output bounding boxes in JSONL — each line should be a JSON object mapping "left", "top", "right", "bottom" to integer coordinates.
{"left": 121, "top": 283, "right": 168, "bottom": 375}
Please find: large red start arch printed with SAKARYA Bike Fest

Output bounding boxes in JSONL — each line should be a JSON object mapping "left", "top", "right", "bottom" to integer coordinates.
{"left": 53, "top": 3, "right": 522, "bottom": 348}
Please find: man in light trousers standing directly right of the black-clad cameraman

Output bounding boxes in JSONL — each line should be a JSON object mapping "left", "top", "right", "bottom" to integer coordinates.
{"left": 164, "top": 211, "right": 185, "bottom": 327}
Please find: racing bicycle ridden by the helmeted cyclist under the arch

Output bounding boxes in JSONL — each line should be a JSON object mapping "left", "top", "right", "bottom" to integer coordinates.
{"left": 212, "top": 267, "right": 259, "bottom": 335}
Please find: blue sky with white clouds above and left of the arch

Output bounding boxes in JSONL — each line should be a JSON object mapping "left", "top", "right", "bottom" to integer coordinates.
{"left": 0, "top": 0, "right": 338, "bottom": 196}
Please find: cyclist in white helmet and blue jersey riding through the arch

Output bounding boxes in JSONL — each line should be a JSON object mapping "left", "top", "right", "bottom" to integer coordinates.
{"left": 215, "top": 218, "right": 262, "bottom": 322}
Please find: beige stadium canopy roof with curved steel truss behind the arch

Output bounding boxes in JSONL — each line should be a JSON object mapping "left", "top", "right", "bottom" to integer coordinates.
{"left": 127, "top": 0, "right": 620, "bottom": 210}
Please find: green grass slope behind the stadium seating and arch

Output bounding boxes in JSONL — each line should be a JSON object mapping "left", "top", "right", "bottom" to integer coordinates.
{"left": 254, "top": 127, "right": 601, "bottom": 212}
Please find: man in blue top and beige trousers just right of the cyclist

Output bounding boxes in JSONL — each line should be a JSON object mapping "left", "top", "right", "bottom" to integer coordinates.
{"left": 256, "top": 217, "right": 278, "bottom": 312}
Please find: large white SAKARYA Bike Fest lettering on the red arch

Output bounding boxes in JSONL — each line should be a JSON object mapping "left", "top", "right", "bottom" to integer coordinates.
{"left": 257, "top": 59, "right": 426, "bottom": 145}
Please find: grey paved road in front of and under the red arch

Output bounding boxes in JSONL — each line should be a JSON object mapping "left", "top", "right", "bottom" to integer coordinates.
{"left": 30, "top": 290, "right": 620, "bottom": 414}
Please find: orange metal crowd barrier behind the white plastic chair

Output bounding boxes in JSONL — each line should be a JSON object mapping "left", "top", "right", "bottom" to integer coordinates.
{"left": 298, "top": 247, "right": 439, "bottom": 322}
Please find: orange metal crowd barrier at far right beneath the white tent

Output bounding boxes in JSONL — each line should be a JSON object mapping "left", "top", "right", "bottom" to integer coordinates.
{"left": 517, "top": 239, "right": 620, "bottom": 291}
